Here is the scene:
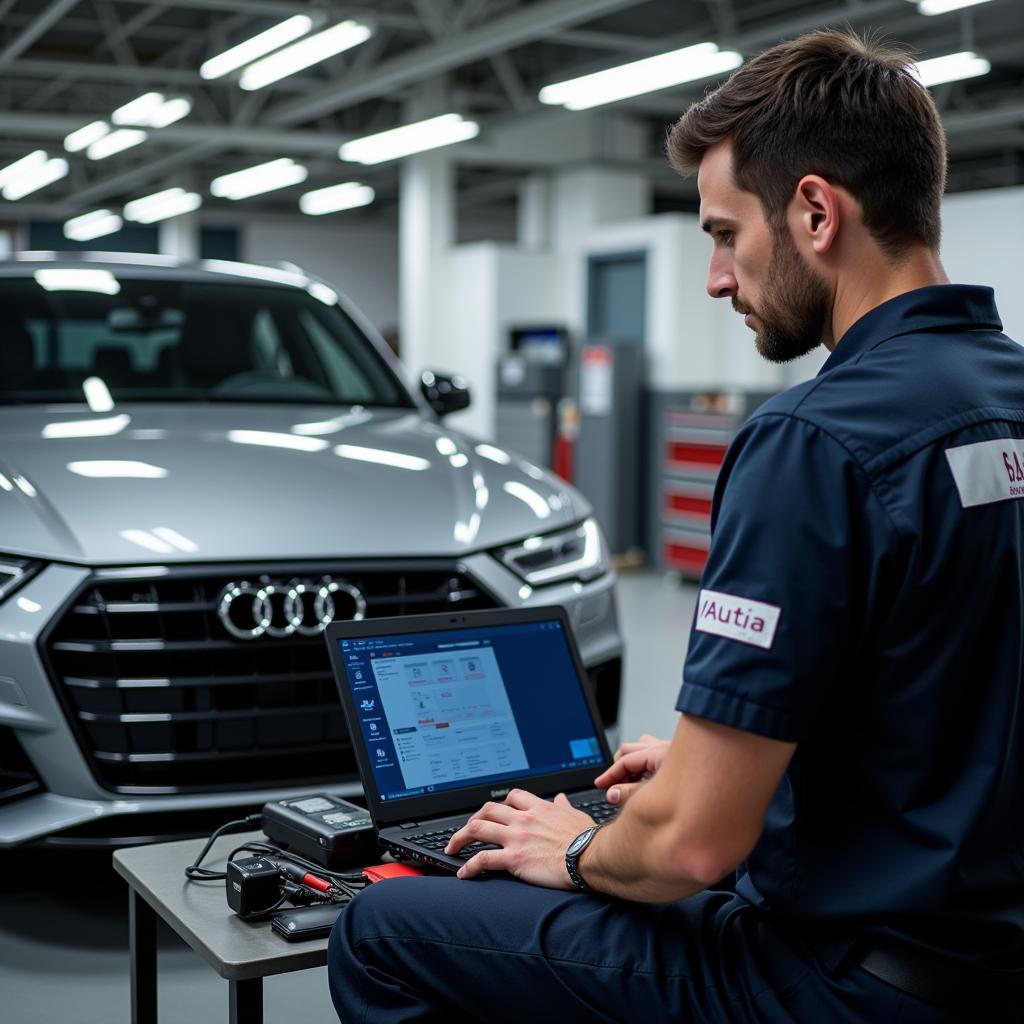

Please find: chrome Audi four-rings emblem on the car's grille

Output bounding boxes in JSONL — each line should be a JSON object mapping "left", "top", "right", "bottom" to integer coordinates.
{"left": 217, "top": 577, "right": 367, "bottom": 640}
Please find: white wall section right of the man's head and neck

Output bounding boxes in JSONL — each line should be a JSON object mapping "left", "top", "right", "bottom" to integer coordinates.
{"left": 942, "top": 188, "right": 1024, "bottom": 344}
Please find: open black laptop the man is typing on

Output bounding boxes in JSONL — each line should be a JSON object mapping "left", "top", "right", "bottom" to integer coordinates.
{"left": 326, "top": 607, "right": 616, "bottom": 871}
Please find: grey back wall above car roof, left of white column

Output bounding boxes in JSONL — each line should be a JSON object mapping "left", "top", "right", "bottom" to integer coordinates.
{"left": 241, "top": 214, "right": 398, "bottom": 330}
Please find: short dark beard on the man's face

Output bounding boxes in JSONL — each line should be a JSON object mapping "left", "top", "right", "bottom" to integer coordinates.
{"left": 732, "top": 226, "right": 831, "bottom": 362}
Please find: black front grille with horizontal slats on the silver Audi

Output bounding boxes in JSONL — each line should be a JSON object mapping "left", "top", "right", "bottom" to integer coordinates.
{"left": 44, "top": 562, "right": 495, "bottom": 793}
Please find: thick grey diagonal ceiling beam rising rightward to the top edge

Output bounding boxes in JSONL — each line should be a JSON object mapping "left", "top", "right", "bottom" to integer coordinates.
{"left": 267, "top": 0, "right": 651, "bottom": 125}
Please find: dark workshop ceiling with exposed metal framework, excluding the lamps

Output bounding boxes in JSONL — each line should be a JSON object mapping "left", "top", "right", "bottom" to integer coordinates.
{"left": 0, "top": 0, "right": 1024, "bottom": 232}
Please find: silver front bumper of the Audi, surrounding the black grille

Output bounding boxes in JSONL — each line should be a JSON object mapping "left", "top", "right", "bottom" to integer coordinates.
{"left": 0, "top": 554, "right": 623, "bottom": 848}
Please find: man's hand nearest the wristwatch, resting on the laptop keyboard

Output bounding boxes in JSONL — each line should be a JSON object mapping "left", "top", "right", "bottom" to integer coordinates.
{"left": 444, "top": 790, "right": 594, "bottom": 889}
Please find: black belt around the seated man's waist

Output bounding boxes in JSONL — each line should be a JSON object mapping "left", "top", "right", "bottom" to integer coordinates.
{"left": 854, "top": 937, "right": 1024, "bottom": 1024}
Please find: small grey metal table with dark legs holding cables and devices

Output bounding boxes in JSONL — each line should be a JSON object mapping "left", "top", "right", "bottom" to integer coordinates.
{"left": 114, "top": 833, "right": 337, "bottom": 1024}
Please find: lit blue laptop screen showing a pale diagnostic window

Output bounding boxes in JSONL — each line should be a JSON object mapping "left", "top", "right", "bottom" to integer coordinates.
{"left": 337, "top": 620, "right": 604, "bottom": 801}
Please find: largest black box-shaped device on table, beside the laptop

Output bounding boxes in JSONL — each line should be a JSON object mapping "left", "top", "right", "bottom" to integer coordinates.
{"left": 263, "top": 793, "right": 380, "bottom": 871}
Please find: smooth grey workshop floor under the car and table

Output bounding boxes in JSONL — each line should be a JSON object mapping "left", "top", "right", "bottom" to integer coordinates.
{"left": 0, "top": 571, "right": 696, "bottom": 1024}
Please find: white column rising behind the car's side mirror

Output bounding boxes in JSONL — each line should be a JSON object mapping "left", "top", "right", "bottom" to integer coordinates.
{"left": 398, "top": 150, "right": 456, "bottom": 377}
